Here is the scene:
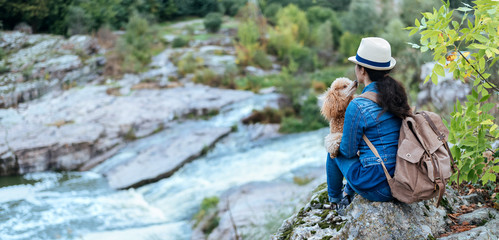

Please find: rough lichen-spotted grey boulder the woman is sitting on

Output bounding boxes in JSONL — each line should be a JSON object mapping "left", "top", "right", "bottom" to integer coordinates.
{"left": 272, "top": 184, "right": 497, "bottom": 240}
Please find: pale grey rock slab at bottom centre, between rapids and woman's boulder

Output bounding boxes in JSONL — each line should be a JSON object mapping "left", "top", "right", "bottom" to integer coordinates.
{"left": 191, "top": 169, "right": 325, "bottom": 240}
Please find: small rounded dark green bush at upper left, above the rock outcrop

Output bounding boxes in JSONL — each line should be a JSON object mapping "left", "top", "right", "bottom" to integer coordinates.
{"left": 66, "top": 6, "right": 94, "bottom": 36}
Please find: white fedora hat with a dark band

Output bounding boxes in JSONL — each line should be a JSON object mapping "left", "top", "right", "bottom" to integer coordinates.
{"left": 348, "top": 37, "right": 397, "bottom": 70}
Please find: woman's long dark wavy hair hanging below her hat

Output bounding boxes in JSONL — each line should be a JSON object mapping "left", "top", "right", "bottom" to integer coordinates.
{"left": 364, "top": 65, "right": 412, "bottom": 119}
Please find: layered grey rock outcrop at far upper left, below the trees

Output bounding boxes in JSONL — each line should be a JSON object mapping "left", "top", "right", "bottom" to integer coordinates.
{"left": 0, "top": 32, "right": 105, "bottom": 108}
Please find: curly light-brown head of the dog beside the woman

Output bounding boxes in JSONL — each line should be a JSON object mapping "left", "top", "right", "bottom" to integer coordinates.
{"left": 321, "top": 78, "right": 357, "bottom": 120}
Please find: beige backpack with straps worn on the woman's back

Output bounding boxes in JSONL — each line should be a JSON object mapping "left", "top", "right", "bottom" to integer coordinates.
{"left": 359, "top": 92, "right": 454, "bottom": 206}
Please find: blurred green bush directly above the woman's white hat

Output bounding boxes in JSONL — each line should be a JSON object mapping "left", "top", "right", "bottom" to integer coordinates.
{"left": 342, "top": 0, "right": 384, "bottom": 35}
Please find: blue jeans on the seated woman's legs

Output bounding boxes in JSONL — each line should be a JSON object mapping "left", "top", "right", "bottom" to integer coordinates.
{"left": 326, "top": 153, "right": 393, "bottom": 203}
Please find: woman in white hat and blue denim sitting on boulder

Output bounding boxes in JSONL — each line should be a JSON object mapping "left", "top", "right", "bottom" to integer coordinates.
{"left": 326, "top": 37, "right": 411, "bottom": 210}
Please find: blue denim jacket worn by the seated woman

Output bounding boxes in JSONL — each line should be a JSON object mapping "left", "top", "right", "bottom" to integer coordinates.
{"left": 340, "top": 82, "right": 402, "bottom": 167}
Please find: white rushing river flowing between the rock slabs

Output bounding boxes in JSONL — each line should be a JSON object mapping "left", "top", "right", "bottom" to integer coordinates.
{"left": 0, "top": 94, "right": 327, "bottom": 240}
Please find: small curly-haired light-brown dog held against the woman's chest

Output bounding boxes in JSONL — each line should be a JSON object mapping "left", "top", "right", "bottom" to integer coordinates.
{"left": 321, "top": 78, "right": 357, "bottom": 158}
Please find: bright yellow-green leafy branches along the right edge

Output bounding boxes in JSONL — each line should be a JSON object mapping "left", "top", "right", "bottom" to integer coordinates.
{"left": 407, "top": 0, "right": 499, "bottom": 183}
